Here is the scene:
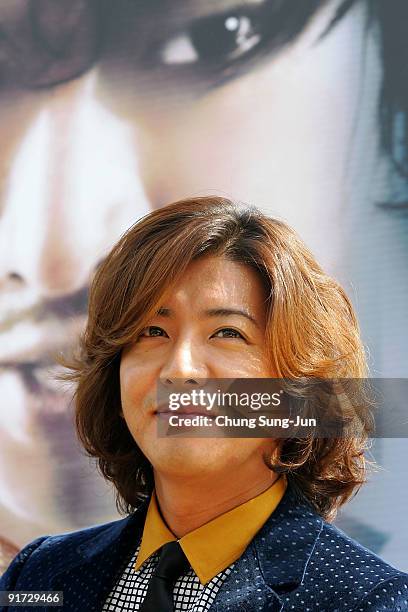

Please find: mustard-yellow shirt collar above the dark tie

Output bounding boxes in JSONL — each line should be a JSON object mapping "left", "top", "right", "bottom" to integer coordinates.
{"left": 135, "top": 475, "right": 287, "bottom": 584}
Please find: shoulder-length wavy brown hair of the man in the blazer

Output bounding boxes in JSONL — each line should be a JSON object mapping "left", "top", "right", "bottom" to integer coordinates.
{"left": 62, "top": 197, "right": 368, "bottom": 520}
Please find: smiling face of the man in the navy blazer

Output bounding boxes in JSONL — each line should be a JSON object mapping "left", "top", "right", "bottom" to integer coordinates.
{"left": 120, "top": 256, "right": 275, "bottom": 478}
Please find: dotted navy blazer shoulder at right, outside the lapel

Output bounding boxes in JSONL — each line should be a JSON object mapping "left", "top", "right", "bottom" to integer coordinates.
{"left": 304, "top": 521, "right": 408, "bottom": 611}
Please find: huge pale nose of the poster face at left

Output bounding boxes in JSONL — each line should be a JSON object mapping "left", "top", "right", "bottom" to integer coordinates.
{"left": 0, "top": 77, "right": 149, "bottom": 297}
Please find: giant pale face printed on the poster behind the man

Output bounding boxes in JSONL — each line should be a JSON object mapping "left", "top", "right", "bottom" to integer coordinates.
{"left": 0, "top": 0, "right": 378, "bottom": 543}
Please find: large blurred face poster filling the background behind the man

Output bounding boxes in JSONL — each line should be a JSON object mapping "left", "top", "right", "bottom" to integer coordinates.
{"left": 0, "top": 0, "right": 408, "bottom": 571}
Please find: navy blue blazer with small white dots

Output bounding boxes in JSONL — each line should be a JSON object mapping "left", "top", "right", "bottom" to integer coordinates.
{"left": 0, "top": 486, "right": 408, "bottom": 612}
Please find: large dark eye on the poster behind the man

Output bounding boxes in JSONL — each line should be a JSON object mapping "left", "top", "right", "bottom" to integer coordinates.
{"left": 160, "top": 13, "right": 261, "bottom": 65}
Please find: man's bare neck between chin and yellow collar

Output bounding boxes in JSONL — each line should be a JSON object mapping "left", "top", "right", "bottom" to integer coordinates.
{"left": 155, "top": 470, "right": 279, "bottom": 538}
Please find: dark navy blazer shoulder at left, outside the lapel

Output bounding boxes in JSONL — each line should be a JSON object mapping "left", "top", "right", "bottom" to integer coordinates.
{"left": 0, "top": 515, "right": 132, "bottom": 590}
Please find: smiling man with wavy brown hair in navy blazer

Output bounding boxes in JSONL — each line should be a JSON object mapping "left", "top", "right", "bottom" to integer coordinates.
{"left": 0, "top": 197, "right": 408, "bottom": 612}
